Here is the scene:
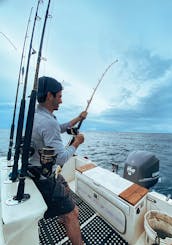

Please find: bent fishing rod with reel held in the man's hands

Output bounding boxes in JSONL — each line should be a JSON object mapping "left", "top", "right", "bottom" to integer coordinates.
{"left": 68, "top": 59, "right": 118, "bottom": 145}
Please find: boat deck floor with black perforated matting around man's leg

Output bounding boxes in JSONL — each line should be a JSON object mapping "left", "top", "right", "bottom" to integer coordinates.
{"left": 39, "top": 192, "right": 128, "bottom": 245}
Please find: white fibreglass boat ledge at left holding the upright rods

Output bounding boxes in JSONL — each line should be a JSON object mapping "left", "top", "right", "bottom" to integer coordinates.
{"left": 1, "top": 167, "right": 47, "bottom": 245}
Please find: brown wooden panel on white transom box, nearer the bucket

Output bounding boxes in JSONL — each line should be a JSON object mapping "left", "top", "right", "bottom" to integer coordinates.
{"left": 119, "top": 184, "right": 148, "bottom": 206}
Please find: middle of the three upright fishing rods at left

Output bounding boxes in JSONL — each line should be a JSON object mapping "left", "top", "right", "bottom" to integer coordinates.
{"left": 10, "top": 0, "right": 41, "bottom": 182}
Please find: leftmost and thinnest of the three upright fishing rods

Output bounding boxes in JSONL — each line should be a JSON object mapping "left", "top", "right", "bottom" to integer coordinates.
{"left": 7, "top": 8, "right": 33, "bottom": 161}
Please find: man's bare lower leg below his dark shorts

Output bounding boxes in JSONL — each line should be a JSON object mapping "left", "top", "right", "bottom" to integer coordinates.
{"left": 63, "top": 206, "right": 84, "bottom": 245}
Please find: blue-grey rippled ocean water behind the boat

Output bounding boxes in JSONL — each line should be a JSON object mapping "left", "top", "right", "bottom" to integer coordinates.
{"left": 0, "top": 130, "right": 172, "bottom": 195}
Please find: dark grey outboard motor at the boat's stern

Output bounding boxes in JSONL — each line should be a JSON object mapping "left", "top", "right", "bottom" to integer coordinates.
{"left": 123, "top": 151, "right": 159, "bottom": 188}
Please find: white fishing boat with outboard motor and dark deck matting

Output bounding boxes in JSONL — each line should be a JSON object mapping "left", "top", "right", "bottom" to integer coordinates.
{"left": 0, "top": 148, "right": 172, "bottom": 245}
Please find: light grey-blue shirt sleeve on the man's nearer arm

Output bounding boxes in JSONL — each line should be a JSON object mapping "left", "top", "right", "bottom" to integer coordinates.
{"left": 40, "top": 119, "right": 76, "bottom": 166}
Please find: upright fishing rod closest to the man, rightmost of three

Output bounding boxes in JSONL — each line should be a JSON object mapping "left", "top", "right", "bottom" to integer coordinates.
{"left": 14, "top": 0, "right": 51, "bottom": 202}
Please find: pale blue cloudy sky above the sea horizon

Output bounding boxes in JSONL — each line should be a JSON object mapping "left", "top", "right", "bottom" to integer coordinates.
{"left": 0, "top": 0, "right": 172, "bottom": 133}
